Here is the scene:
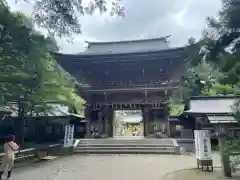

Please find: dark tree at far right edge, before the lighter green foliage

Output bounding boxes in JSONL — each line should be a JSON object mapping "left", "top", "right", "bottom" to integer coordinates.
{"left": 206, "top": 0, "right": 240, "bottom": 119}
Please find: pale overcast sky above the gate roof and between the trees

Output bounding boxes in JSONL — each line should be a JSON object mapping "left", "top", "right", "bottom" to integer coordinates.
{"left": 8, "top": 0, "right": 221, "bottom": 53}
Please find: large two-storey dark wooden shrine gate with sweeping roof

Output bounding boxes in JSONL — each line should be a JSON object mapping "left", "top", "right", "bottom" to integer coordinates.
{"left": 53, "top": 37, "right": 187, "bottom": 138}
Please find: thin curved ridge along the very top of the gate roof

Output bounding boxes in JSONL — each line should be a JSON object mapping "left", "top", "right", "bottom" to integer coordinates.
{"left": 84, "top": 35, "right": 171, "bottom": 46}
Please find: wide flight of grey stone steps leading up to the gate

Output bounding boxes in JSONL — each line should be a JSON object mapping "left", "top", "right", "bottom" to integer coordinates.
{"left": 74, "top": 138, "right": 176, "bottom": 154}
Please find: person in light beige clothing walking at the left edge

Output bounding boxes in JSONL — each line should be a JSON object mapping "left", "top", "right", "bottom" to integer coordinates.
{"left": 0, "top": 135, "right": 19, "bottom": 179}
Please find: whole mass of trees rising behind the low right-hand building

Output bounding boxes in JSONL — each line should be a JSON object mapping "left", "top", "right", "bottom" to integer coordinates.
{"left": 172, "top": 0, "right": 240, "bottom": 117}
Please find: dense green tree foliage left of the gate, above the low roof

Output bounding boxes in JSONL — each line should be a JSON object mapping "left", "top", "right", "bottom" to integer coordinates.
{"left": 0, "top": 6, "right": 84, "bottom": 115}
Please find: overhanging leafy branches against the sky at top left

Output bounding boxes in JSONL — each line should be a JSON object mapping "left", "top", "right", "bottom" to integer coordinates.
{"left": 6, "top": 0, "right": 124, "bottom": 36}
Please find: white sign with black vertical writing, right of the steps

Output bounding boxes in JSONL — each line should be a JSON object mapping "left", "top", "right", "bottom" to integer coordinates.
{"left": 194, "top": 130, "right": 212, "bottom": 160}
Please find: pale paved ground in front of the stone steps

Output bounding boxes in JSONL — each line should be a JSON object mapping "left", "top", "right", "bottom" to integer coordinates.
{"left": 12, "top": 154, "right": 220, "bottom": 180}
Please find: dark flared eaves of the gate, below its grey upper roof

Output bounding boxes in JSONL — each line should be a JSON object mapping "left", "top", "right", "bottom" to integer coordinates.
{"left": 53, "top": 47, "right": 187, "bottom": 88}
